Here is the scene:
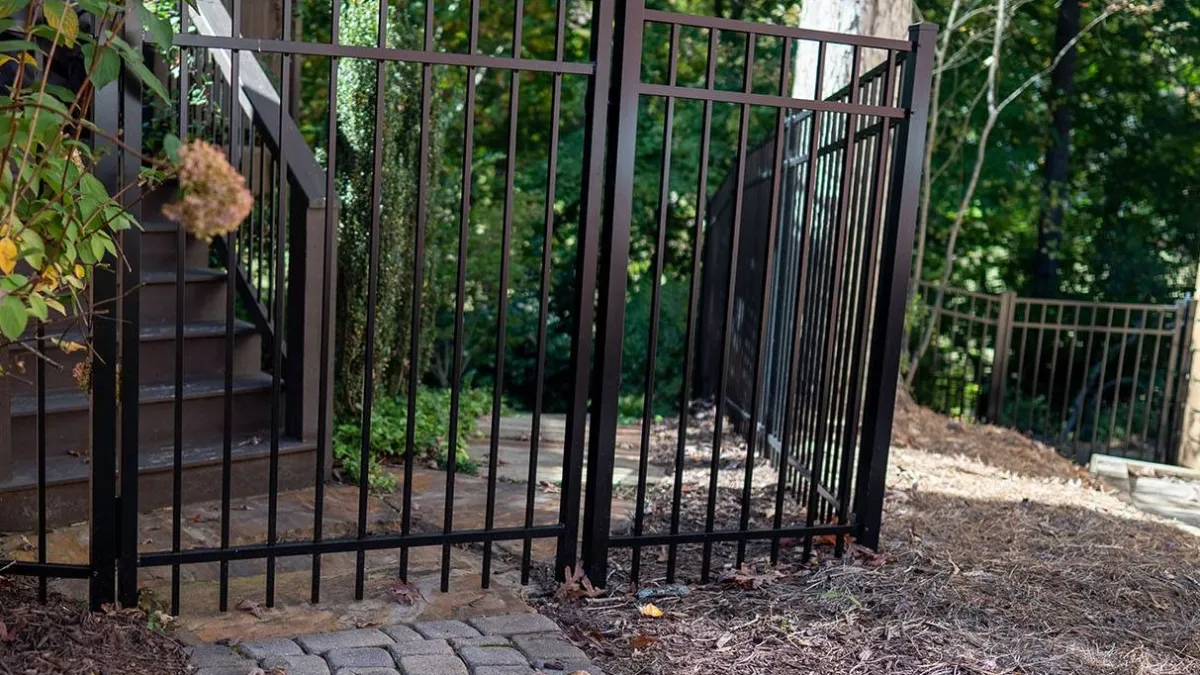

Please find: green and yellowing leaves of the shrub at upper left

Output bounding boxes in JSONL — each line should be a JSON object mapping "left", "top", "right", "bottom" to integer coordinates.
{"left": 0, "top": 0, "right": 170, "bottom": 347}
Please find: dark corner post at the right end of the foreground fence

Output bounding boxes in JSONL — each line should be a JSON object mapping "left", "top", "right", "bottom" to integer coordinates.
{"left": 854, "top": 23, "right": 937, "bottom": 549}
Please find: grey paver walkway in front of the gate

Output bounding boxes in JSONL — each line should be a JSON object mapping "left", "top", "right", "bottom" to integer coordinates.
{"left": 190, "top": 614, "right": 601, "bottom": 675}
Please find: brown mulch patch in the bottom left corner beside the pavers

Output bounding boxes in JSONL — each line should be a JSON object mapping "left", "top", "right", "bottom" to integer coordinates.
{"left": 0, "top": 577, "right": 187, "bottom": 675}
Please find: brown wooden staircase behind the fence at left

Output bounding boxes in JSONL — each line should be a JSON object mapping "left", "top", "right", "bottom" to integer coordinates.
{"left": 0, "top": 186, "right": 316, "bottom": 531}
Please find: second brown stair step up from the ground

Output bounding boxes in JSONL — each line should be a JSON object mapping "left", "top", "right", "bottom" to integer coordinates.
{"left": 11, "top": 374, "right": 280, "bottom": 459}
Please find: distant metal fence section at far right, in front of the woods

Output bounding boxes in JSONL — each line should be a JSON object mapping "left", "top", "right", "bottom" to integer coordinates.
{"left": 910, "top": 282, "right": 1196, "bottom": 464}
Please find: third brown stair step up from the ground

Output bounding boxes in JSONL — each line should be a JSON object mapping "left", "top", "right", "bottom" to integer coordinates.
{"left": 11, "top": 319, "right": 263, "bottom": 396}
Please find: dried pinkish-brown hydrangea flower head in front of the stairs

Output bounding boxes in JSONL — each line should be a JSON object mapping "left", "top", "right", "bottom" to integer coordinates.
{"left": 162, "top": 141, "right": 254, "bottom": 241}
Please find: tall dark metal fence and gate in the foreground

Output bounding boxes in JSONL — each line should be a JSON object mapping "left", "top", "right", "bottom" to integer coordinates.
{"left": 0, "top": 0, "right": 935, "bottom": 613}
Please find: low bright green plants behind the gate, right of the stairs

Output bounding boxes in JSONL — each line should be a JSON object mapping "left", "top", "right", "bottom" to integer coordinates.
{"left": 334, "top": 387, "right": 492, "bottom": 491}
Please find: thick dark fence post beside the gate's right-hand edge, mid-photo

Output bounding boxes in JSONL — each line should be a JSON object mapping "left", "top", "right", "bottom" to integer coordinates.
{"left": 583, "top": 0, "right": 644, "bottom": 585}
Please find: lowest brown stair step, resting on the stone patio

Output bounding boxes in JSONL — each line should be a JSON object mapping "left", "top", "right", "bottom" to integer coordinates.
{"left": 0, "top": 436, "right": 316, "bottom": 532}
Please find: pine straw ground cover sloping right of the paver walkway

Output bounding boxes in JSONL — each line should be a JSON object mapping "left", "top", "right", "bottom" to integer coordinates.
{"left": 539, "top": 404, "right": 1200, "bottom": 675}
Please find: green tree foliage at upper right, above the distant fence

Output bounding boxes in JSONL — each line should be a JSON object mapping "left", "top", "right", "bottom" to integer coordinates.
{"left": 917, "top": 0, "right": 1200, "bottom": 303}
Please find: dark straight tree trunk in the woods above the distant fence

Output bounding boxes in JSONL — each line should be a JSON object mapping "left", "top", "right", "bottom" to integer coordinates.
{"left": 1033, "top": 0, "right": 1081, "bottom": 298}
